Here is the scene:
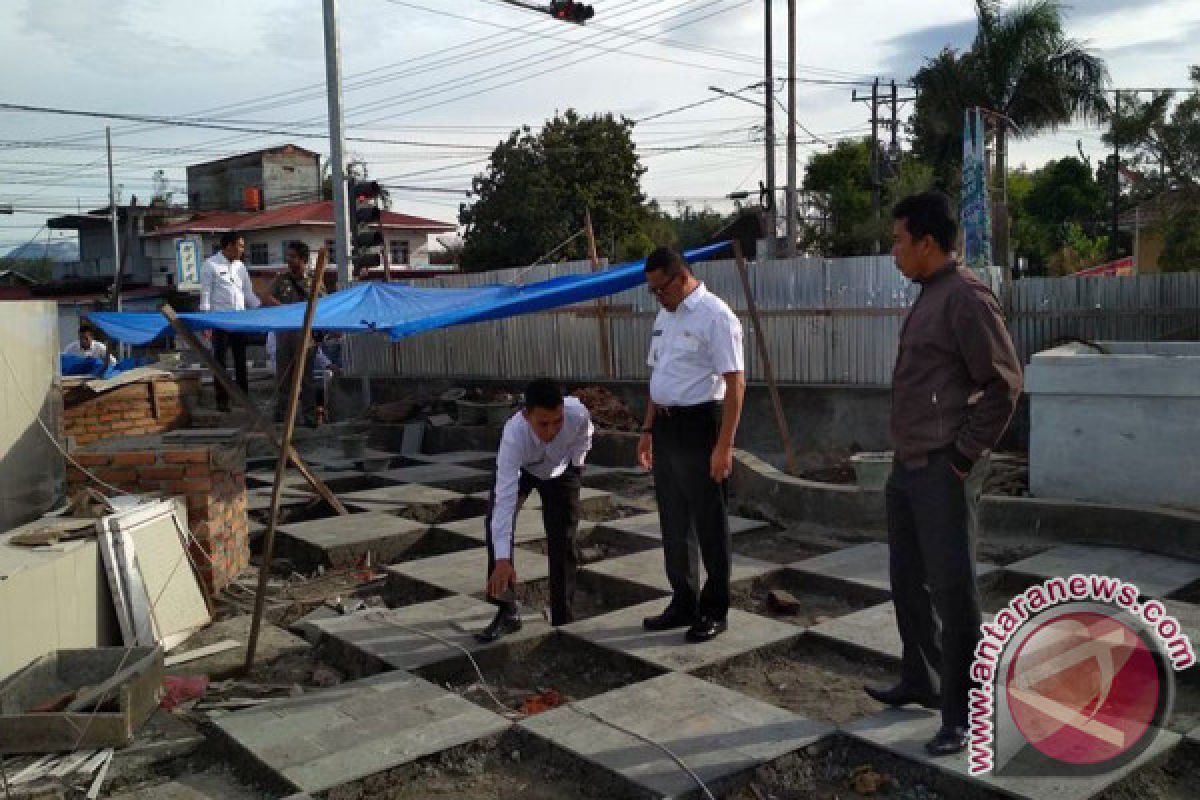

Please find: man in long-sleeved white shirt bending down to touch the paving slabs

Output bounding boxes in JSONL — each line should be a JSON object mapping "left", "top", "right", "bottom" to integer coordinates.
{"left": 475, "top": 380, "right": 593, "bottom": 642}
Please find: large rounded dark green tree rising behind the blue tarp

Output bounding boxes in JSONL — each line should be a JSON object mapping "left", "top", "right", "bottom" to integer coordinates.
{"left": 458, "top": 110, "right": 646, "bottom": 271}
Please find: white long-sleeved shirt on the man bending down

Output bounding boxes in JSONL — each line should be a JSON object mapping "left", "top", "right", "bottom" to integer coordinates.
{"left": 491, "top": 397, "right": 593, "bottom": 559}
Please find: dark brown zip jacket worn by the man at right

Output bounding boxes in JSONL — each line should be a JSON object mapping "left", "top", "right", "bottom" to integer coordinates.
{"left": 892, "top": 261, "right": 1021, "bottom": 471}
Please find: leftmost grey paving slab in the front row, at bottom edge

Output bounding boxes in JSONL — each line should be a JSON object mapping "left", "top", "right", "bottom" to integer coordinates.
{"left": 215, "top": 672, "right": 509, "bottom": 792}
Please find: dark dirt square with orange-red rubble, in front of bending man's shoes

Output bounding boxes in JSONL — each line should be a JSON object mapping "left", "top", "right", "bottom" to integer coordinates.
{"left": 415, "top": 634, "right": 662, "bottom": 711}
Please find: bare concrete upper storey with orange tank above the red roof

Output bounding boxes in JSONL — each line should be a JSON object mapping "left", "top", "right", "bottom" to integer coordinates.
{"left": 187, "top": 144, "right": 322, "bottom": 211}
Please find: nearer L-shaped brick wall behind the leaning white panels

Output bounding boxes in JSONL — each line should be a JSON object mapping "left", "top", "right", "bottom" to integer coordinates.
{"left": 67, "top": 445, "right": 250, "bottom": 593}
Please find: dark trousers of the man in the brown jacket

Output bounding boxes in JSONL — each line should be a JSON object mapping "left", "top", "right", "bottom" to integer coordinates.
{"left": 886, "top": 453, "right": 988, "bottom": 727}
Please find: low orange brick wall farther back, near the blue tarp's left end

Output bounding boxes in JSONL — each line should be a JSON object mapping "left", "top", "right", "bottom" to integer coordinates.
{"left": 62, "top": 375, "right": 200, "bottom": 447}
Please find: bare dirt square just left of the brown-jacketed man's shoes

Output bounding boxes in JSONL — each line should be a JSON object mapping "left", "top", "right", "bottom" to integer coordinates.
{"left": 697, "top": 637, "right": 895, "bottom": 724}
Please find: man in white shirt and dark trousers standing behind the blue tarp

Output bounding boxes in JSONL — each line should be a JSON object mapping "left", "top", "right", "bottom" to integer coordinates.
{"left": 199, "top": 230, "right": 263, "bottom": 411}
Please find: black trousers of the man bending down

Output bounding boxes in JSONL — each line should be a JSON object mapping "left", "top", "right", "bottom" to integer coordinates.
{"left": 485, "top": 467, "right": 583, "bottom": 626}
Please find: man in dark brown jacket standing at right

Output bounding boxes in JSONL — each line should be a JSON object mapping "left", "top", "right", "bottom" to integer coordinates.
{"left": 866, "top": 192, "right": 1021, "bottom": 756}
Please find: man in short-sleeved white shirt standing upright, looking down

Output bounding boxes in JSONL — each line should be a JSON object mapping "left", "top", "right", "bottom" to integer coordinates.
{"left": 637, "top": 247, "right": 745, "bottom": 642}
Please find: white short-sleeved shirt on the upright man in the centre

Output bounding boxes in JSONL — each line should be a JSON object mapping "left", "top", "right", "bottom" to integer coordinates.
{"left": 646, "top": 283, "right": 745, "bottom": 405}
